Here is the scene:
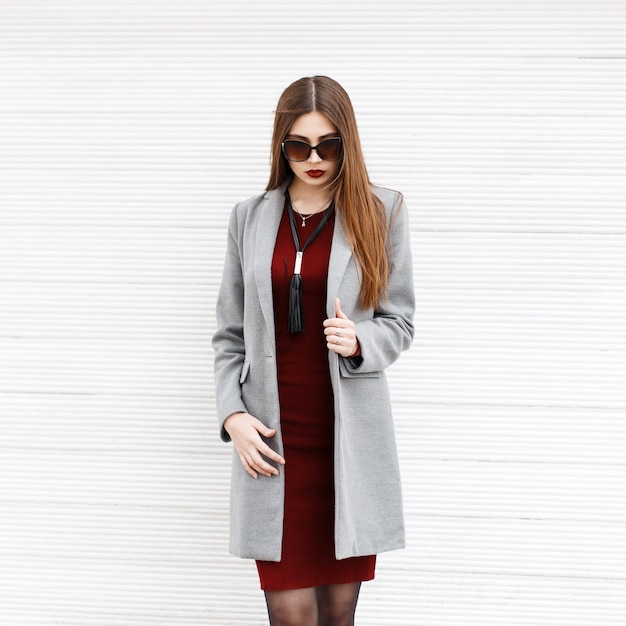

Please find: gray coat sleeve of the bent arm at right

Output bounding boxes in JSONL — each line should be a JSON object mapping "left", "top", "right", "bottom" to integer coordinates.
{"left": 340, "top": 194, "right": 415, "bottom": 376}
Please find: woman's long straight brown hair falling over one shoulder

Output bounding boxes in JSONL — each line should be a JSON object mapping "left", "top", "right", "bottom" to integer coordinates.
{"left": 267, "top": 76, "right": 389, "bottom": 308}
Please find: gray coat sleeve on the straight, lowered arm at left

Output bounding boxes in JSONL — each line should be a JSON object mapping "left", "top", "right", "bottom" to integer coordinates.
{"left": 212, "top": 206, "right": 246, "bottom": 441}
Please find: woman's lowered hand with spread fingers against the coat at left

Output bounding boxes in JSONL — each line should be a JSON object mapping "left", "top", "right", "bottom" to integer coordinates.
{"left": 224, "top": 413, "right": 285, "bottom": 478}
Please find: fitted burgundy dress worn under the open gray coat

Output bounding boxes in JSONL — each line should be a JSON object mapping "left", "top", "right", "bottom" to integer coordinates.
{"left": 257, "top": 209, "right": 376, "bottom": 591}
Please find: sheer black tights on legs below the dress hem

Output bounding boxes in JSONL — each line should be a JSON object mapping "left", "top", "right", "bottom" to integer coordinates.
{"left": 265, "top": 583, "right": 361, "bottom": 626}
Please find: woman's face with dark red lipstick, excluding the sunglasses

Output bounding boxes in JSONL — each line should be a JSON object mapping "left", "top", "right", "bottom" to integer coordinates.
{"left": 285, "top": 111, "right": 341, "bottom": 191}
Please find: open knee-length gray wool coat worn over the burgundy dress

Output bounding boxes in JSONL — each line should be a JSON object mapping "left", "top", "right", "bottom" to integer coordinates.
{"left": 213, "top": 178, "right": 415, "bottom": 561}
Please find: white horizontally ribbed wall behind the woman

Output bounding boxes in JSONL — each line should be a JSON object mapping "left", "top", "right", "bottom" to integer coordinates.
{"left": 0, "top": 0, "right": 626, "bottom": 626}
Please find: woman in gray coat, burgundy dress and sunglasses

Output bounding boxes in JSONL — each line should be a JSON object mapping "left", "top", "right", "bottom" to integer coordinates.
{"left": 213, "top": 76, "right": 414, "bottom": 626}
